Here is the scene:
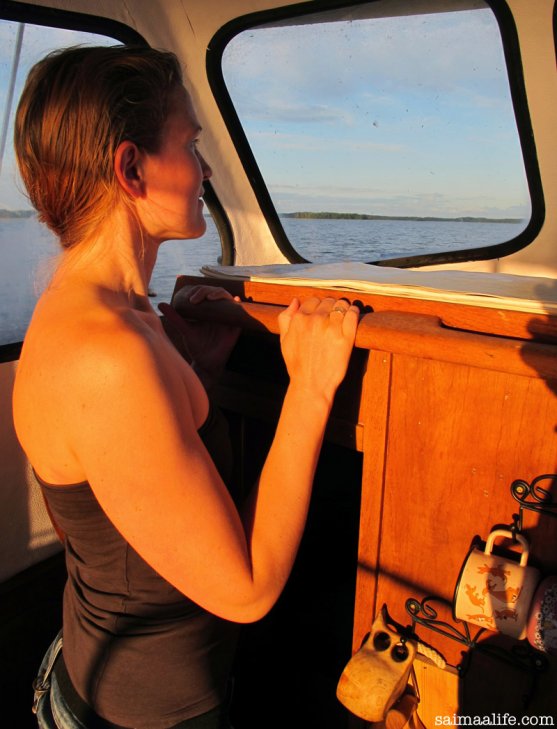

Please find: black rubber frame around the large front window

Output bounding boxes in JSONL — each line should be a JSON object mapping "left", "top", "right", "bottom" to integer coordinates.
{"left": 206, "top": 0, "right": 545, "bottom": 268}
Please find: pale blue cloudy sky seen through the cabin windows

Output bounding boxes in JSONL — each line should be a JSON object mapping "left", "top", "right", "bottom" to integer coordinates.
{"left": 0, "top": 4, "right": 530, "bottom": 218}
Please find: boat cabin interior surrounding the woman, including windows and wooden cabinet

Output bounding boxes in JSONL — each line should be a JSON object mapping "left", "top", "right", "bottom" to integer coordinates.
{"left": 0, "top": 0, "right": 557, "bottom": 729}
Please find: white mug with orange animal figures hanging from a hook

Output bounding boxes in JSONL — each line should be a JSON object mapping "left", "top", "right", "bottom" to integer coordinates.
{"left": 454, "top": 529, "right": 540, "bottom": 638}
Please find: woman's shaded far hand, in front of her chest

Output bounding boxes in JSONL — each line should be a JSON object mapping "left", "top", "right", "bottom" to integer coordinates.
{"left": 159, "top": 285, "right": 240, "bottom": 388}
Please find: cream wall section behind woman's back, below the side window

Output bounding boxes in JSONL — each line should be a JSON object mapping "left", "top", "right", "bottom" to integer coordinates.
{"left": 0, "top": 362, "right": 61, "bottom": 583}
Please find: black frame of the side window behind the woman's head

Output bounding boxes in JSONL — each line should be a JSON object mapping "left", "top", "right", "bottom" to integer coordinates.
{"left": 0, "top": 0, "right": 235, "bottom": 350}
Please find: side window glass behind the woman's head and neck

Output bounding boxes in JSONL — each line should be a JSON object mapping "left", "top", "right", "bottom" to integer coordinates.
{"left": 0, "top": 20, "right": 221, "bottom": 346}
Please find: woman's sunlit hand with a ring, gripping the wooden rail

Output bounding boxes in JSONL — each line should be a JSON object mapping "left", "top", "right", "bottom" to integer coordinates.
{"left": 279, "top": 297, "right": 360, "bottom": 401}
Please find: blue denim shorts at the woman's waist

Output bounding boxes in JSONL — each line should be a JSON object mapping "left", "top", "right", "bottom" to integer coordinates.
{"left": 33, "top": 631, "right": 233, "bottom": 729}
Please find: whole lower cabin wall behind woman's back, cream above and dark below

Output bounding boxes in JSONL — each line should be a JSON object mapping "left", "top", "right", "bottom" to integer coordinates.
{"left": 0, "top": 354, "right": 66, "bottom": 729}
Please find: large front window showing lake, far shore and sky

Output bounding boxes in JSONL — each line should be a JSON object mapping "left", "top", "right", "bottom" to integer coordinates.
{"left": 222, "top": 0, "right": 532, "bottom": 265}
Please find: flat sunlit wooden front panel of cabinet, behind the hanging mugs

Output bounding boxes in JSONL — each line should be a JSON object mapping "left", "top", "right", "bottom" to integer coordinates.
{"left": 378, "top": 355, "right": 557, "bottom": 663}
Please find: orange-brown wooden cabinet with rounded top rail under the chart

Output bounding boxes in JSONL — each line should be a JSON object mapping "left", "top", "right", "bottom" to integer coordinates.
{"left": 173, "top": 280, "right": 557, "bottom": 721}
